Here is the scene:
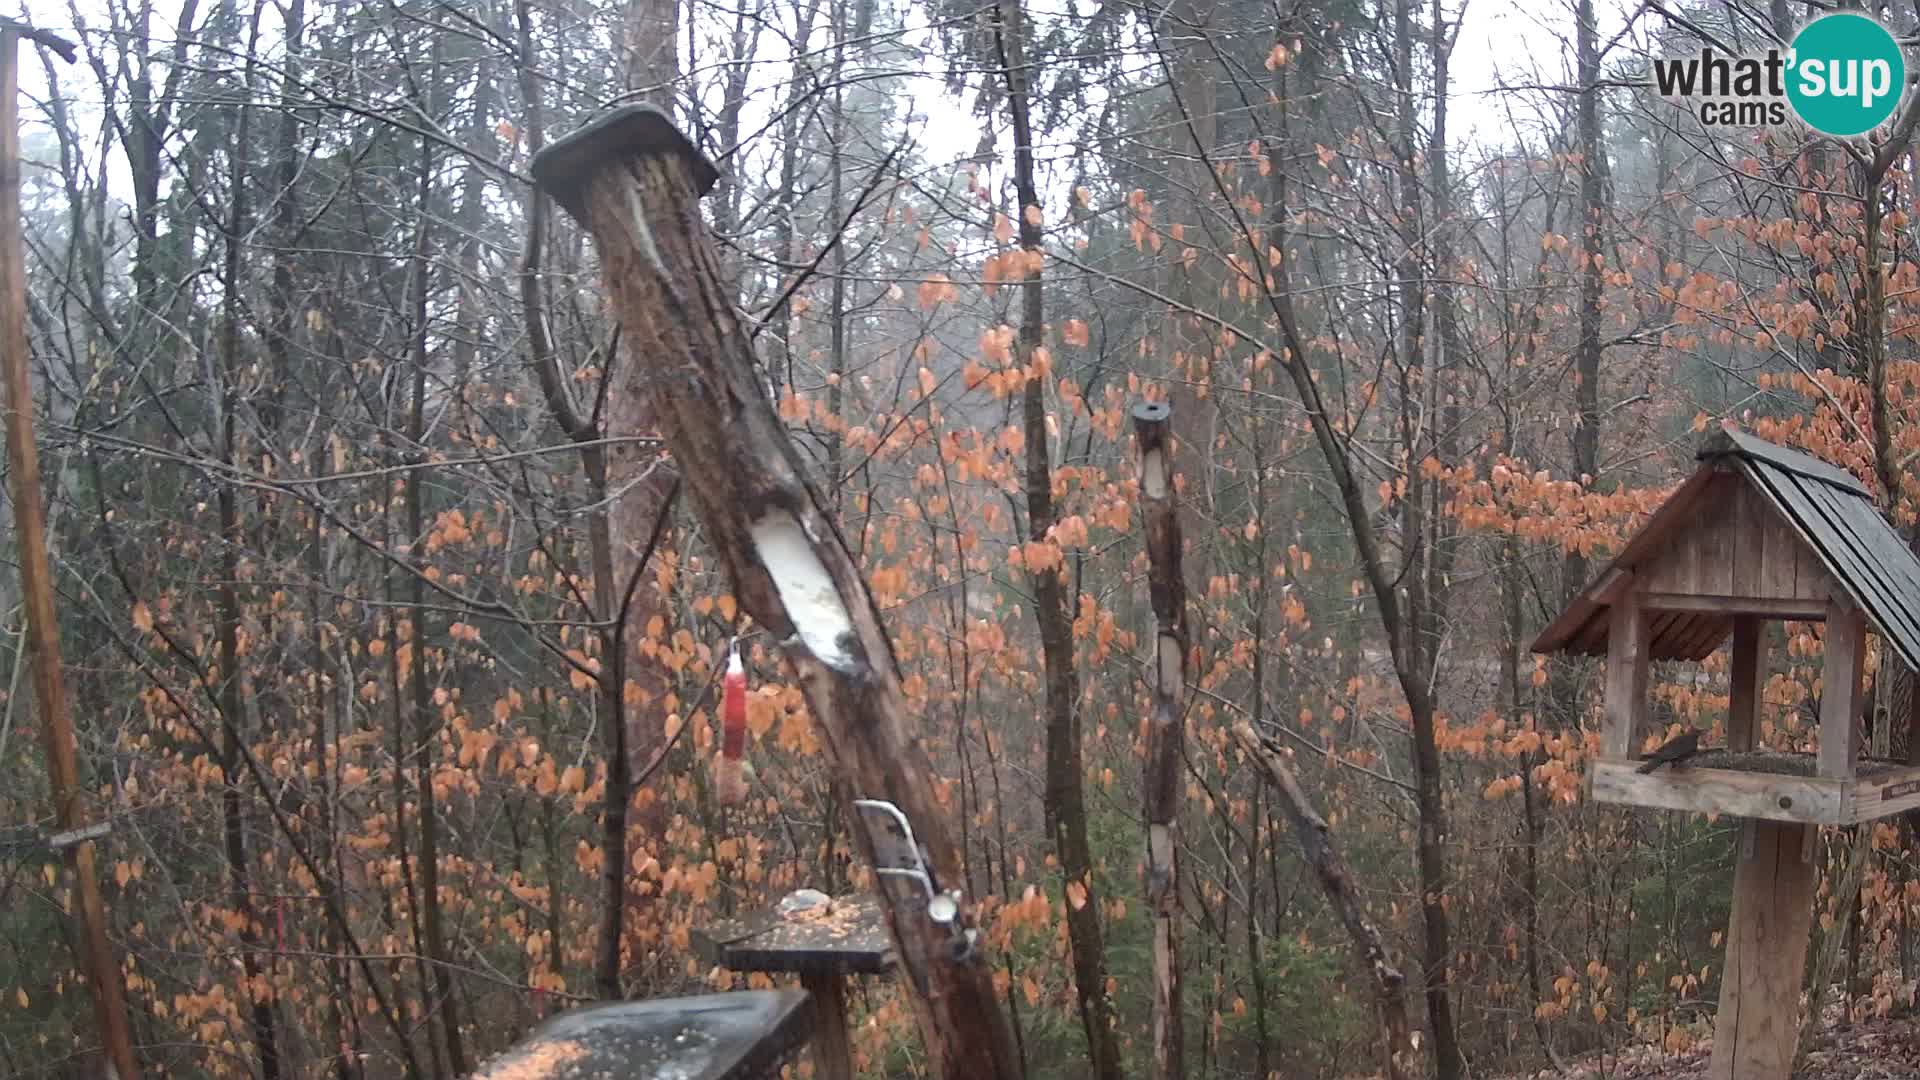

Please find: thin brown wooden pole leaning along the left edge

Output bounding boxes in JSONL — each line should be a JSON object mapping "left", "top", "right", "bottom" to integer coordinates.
{"left": 0, "top": 21, "right": 140, "bottom": 1080}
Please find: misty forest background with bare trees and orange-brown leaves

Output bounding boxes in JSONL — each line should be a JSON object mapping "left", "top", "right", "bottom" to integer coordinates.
{"left": 0, "top": 0, "right": 1920, "bottom": 1080}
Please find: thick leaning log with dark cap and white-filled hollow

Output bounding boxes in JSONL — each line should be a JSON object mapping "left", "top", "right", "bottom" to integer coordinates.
{"left": 532, "top": 106, "right": 1021, "bottom": 1080}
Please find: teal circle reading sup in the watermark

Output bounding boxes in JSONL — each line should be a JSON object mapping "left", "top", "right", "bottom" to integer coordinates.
{"left": 1788, "top": 12, "right": 1907, "bottom": 138}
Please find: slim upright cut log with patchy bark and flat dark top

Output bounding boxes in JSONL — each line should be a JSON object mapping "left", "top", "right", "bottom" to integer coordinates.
{"left": 1133, "top": 402, "right": 1187, "bottom": 1080}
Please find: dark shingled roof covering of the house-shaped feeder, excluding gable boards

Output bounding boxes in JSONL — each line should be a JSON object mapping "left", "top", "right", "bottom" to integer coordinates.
{"left": 1534, "top": 430, "right": 1920, "bottom": 669}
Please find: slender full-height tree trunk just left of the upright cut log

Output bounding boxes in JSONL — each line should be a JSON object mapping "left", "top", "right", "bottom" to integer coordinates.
{"left": 995, "top": 0, "right": 1121, "bottom": 1080}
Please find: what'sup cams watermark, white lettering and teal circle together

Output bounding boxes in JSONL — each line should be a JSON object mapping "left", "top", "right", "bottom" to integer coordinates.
{"left": 1653, "top": 12, "right": 1907, "bottom": 138}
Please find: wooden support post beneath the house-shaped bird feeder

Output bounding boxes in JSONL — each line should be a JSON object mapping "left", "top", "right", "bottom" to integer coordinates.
{"left": 1707, "top": 821, "right": 1816, "bottom": 1080}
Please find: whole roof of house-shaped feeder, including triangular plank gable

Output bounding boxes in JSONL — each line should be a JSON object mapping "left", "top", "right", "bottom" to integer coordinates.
{"left": 1532, "top": 430, "right": 1920, "bottom": 669}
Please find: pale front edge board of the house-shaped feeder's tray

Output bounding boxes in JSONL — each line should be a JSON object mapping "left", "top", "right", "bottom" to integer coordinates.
{"left": 1588, "top": 757, "right": 1853, "bottom": 824}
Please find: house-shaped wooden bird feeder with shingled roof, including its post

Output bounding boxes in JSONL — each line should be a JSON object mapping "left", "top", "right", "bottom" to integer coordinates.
{"left": 1534, "top": 430, "right": 1920, "bottom": 1080}
